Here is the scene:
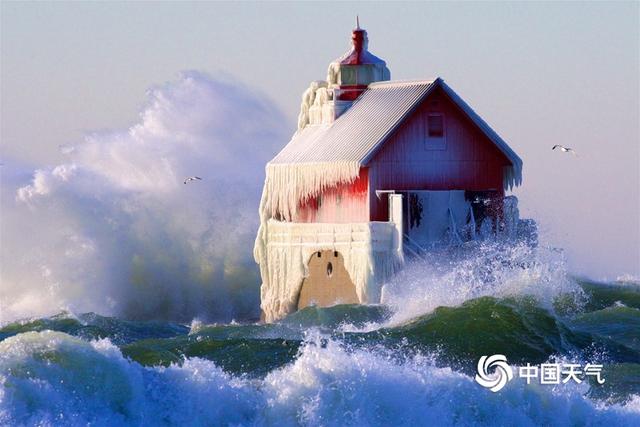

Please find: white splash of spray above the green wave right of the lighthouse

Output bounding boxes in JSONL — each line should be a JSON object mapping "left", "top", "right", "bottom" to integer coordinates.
{"left": 383, "top": 242, "right": 584, "bottom": 325}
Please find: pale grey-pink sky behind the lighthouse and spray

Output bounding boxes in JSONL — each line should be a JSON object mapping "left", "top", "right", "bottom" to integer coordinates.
{"left": 0, "top": 2, "right": 640, "bottom": 278}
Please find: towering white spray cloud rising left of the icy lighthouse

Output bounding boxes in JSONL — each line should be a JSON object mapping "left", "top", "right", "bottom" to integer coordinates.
{"left": 0, "top": 72, "right": 287, "bottom": 322}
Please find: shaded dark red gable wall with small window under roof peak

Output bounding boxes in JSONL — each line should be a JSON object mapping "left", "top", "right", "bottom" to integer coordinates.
{"left": 368, "top": 85, "right": 510, "bottom": 221}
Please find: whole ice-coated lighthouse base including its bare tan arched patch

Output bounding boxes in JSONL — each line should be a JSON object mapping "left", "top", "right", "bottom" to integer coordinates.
{"left": 254, "top": 220, "right": 403, "bottom": 322}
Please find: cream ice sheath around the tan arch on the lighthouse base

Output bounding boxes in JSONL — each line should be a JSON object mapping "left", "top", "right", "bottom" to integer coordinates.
{"left": 255, "top": 219, "right": 402, "bottom": 322}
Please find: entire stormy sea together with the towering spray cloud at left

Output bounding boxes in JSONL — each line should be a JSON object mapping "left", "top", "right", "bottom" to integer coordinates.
{"left": 0, "top": 72, "right": 640, "bottom": 426}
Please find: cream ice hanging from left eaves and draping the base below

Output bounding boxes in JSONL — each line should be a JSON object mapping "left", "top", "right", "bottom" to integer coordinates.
{"left": 254, "top": 155, "right": 384, "bottom": 322}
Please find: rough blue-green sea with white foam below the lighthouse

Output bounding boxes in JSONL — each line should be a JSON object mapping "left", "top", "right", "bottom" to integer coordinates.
{"left": 0, "top": 246, "right": 640, "bottom": 426}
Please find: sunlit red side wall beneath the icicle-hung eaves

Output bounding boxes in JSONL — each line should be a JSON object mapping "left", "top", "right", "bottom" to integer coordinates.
{"left": 294, "top": 168, "right": 369, "bottom": 223}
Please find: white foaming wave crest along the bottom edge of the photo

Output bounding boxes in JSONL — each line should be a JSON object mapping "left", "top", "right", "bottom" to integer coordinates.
{"left": 0, "top": 332, "right": 640, "bottom": 426}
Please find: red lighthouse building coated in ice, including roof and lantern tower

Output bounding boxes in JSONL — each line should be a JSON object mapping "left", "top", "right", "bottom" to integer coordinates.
{"left": 254, "top": 20, "right": 522, "bottom": 322}
